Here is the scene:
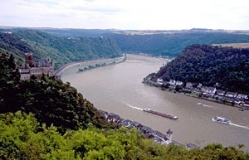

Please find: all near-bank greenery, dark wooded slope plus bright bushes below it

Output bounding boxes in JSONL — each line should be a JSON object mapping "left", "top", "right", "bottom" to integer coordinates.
{"left": 0, "top": 53, "right": 249, "bottom": 160}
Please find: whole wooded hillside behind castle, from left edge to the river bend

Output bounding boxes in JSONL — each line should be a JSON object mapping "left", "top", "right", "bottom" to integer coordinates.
{"left": 0, "top": 30, "right": 121, "bottom": 68}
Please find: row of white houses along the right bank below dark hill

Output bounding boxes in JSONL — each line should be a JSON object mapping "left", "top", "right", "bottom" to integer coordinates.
{"left": 142, "top": 76, "right": 249, "bottom": 111}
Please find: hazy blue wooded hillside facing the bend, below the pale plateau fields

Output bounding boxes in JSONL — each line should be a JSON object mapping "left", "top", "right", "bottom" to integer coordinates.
{"left": 108, "top": 32, "right": 249, "bottom": 57}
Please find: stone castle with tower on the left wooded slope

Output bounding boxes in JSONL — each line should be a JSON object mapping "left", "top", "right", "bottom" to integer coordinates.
{"left": 18, "top": 53, "right": 54, "bottom": 80}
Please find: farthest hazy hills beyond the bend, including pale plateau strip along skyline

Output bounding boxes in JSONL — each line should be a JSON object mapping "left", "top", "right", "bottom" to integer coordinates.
{"left": 42, "top": 28, "right": 249, "bottom": 57}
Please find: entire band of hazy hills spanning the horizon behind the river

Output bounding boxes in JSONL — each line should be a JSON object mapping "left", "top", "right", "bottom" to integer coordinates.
{"left": 0, "top": 27, "right": 249, "bottom": 71}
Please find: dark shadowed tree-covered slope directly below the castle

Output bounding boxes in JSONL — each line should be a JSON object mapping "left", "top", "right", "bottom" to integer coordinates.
{"left": 0, "top": 55, "right": 109, "bottom": 132}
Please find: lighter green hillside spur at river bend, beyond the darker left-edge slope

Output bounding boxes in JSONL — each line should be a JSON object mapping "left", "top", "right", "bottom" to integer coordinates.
{"left": 13, "top": 30, "right": 121, "bottom": 68}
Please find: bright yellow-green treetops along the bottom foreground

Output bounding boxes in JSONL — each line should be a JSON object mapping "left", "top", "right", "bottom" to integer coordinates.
{"left": 0, "top": 112, "right": 249, "bottom": 160}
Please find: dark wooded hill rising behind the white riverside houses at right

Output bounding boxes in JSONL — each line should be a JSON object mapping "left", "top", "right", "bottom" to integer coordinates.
{"left": 156, "top": 44, "right": 249, "bottom": 94}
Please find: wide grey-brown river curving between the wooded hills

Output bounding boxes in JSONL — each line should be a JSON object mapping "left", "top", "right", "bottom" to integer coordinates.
{"left": 62, "top": 55, "right": 249, "bottom": 151}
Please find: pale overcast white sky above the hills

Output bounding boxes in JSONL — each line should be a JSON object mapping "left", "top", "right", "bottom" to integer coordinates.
{"left": 0, "top": 0, "right": 249, "bottom": 30}
